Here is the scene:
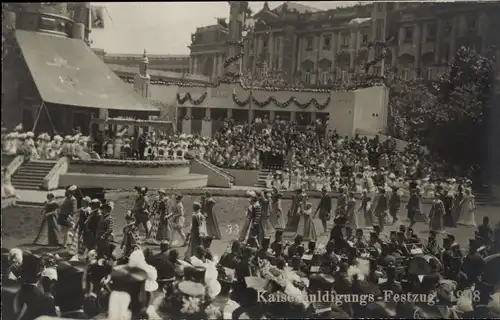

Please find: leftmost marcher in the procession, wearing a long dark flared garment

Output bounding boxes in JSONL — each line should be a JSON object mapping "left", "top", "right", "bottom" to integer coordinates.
{"left": 33, "top": 193, "right": 60, "bottom": 246}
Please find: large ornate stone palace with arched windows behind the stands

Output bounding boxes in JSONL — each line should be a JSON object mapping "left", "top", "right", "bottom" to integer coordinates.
{"left": 190, "top": 2, "right": 500, "bottom": 85}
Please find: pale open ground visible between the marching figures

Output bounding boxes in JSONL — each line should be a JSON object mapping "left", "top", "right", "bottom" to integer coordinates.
{"left": 2, "top": 192, "right": 500, "bottom": 254}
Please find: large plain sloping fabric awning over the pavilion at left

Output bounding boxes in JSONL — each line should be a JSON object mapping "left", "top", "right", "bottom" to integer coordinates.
{"left": 16, "top": 30, "right": 159, "bottom": 112}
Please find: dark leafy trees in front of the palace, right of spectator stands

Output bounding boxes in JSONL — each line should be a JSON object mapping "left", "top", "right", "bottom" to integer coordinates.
{"left": 385, "top": 47, "right": 493, "bottom": 178}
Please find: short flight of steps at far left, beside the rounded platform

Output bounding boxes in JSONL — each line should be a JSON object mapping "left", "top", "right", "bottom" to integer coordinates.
{"left": 11, "top": 160, "right": 56, "bottom": 190}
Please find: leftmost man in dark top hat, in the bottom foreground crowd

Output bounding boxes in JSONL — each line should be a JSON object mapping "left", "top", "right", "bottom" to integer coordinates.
{"left": 14, "top": 254, "right": 57, "bottom": 320}
